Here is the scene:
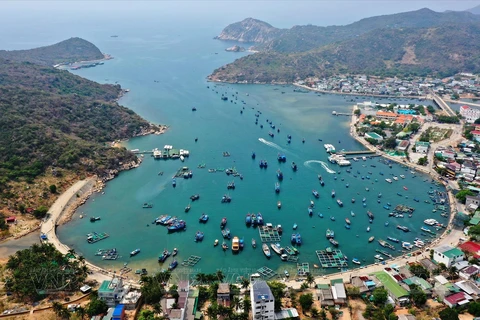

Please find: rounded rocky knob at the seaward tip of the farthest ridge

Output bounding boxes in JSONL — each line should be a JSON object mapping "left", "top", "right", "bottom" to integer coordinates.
{"left": 215, "top": 18, "right": 283, "bottom": 43}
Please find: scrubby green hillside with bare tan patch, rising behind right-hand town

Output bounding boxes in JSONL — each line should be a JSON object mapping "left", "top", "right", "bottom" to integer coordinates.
{"left": 209, "top": 23, "right": 480, "bottom": 83}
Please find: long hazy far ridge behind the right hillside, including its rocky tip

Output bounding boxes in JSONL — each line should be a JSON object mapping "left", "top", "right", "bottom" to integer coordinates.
{"left": 216, "top": 8, "right": 480, "bottom": 52}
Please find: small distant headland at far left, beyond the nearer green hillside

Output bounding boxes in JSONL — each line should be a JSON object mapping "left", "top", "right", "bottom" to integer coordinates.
{"left": 0, "top": 38, "right": 104, "bottom": 66}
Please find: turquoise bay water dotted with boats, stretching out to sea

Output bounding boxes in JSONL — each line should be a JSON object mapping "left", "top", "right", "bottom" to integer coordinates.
{"left": 54, "top": 24, "right": 447, "bottom": 280}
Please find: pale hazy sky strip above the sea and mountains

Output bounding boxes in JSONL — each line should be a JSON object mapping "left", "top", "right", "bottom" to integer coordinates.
{"left": 0, "top": 0, "right": 480, "bottom": 28}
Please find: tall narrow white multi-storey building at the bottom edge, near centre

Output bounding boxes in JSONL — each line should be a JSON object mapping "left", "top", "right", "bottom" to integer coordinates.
{"left": 250, "top": 280, "right": 275, "bottom": 320}
